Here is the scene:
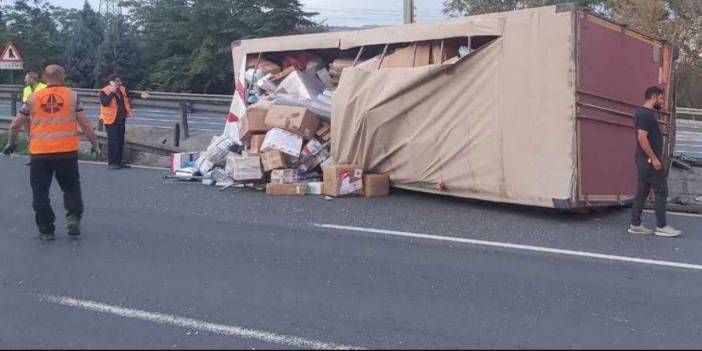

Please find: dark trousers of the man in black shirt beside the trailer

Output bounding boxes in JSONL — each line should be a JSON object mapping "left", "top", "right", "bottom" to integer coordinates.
{"left": 631, "top": 161, "right": 668, "bottom": 228}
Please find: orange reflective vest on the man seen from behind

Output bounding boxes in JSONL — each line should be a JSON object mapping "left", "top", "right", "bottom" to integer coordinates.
{"left": 27, "top": 85, "right": 80, "bottom": 155}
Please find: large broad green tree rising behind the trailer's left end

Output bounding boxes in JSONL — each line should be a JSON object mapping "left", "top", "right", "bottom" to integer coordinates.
{"left": 125, "top": 0, "right": 313, "bottom": 93}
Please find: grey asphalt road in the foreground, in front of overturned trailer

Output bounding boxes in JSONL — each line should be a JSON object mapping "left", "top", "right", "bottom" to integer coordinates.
{"left": 0, "top": 158, "right": 702, "bottom": 348}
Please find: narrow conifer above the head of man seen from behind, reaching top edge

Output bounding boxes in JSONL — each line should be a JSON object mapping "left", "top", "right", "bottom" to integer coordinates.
{"left": 62, "top": 1, "right": 103, "bottom": 88}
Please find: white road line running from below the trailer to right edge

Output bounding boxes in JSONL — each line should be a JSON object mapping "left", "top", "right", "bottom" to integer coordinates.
{"left": 313, "top": 223, "right": 702, "bottom": 271}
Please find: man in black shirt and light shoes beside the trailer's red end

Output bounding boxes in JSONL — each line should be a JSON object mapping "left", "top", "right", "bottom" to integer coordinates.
{"left": 629, "top": 87, "right": 682, "bottom": 237}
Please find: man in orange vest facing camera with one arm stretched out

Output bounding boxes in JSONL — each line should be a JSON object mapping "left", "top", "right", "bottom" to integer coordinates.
{"left": 100, "top": 74, "right": 151, "bottom": 170}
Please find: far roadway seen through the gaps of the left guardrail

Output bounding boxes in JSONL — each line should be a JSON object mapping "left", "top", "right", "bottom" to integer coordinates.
{"left": 0, "top": 100, "right": 227, "bottom": 132}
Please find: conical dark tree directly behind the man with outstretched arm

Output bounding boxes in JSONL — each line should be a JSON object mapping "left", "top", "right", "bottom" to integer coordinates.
{"left": 94, "top": 15, "right": 141, "bottom": 85}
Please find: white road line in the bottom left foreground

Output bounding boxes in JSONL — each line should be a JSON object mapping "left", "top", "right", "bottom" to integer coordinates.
{"left": 39, "top": 295, "right": 362, "bottom": 350}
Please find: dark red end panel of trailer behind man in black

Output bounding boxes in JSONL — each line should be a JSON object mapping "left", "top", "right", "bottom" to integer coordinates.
{"left": 575, "top": 11, "right": 675, "bottom": 206}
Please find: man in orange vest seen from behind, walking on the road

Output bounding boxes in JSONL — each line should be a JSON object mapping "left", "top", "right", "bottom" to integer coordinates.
{"left": 3, "top": 65, "right": 98, "bottom": 240}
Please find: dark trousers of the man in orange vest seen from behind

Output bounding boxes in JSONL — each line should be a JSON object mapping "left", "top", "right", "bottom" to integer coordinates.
{"left": 29, "top": 153, "right": 83, "bottom": 234}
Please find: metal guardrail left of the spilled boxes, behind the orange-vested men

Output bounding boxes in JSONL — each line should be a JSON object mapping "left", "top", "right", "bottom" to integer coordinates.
{"left": 0, "top": 85, "right": 232, "bottom": 138}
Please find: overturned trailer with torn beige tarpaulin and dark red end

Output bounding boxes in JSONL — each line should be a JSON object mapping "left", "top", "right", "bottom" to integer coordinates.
{"left": 225, "top": 6, "right": 675, "bottom": 208}
